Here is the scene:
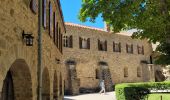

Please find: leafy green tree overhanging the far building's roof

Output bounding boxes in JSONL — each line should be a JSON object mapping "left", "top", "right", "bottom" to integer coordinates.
{"left": 79, "top": 0, "right": 170, "bottom": 64}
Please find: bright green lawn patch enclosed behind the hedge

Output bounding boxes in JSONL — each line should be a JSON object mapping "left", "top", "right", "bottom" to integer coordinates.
{"left": 146, "top": 93, "right": 170, "bottom": 100}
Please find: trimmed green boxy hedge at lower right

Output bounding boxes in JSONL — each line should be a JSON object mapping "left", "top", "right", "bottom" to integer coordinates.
{"left": 115, "top": 81, "right": 170, "bottom": 100}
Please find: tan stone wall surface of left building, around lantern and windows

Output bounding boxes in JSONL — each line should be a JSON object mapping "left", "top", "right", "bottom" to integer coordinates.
{"left": 0, "top": 0, "right": 65, "bottom": 100}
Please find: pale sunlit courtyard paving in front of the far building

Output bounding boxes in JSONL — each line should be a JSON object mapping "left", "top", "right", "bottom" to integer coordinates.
{"left": 64, "top": 92, "right": 116, "bottom": 100}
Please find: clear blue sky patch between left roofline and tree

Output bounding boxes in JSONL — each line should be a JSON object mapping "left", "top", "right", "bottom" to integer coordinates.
{"left": 60, "top": 0, "right": 104, "bottom": 28}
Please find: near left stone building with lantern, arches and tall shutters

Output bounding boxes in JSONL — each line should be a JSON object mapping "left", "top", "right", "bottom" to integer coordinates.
{"left": 0, "top": 0, "right": 66, "bottom": 100}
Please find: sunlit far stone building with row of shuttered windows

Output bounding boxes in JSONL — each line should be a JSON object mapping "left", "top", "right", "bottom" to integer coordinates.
{"left": 63, "top": 23, "right": 154, "bottom": 95}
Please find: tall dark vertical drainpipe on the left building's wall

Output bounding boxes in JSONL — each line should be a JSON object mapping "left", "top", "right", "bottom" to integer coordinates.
{"left": 37, "top": 0, "right": 42, "bottom": 100}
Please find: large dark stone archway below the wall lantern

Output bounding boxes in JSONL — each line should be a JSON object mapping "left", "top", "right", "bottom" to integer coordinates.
{"left": 1, "top": 59, "right": 33, "bottom": 100}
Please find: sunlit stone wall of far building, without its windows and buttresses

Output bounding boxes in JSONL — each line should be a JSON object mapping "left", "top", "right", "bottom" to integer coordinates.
{"left": 63, "top": 23, "right": 152, "bottom": 94}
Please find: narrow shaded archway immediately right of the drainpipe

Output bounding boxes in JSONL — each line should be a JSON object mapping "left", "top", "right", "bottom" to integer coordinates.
{"left": 42, "top": 68, "right": 50, "bottom": 100}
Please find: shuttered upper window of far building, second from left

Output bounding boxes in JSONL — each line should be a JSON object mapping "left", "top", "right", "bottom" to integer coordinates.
{"left": 79, "top": 37, "right": 90, "bottom": 49}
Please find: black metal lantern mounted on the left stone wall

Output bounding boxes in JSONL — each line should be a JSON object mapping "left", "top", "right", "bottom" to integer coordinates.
{"left": 22, "top": 31, "right": 34, "bottom": 46}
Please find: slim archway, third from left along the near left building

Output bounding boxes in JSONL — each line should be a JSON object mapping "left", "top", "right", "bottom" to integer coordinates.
{"left": 53, "top": 71, "right": 59, "bottom": 100}
